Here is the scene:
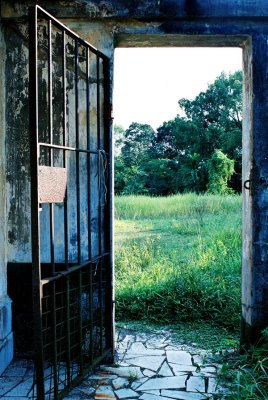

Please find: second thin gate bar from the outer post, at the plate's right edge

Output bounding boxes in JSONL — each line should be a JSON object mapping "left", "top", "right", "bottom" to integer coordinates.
{"left": 62, "top": 31, "right": 69, "bottom": 269}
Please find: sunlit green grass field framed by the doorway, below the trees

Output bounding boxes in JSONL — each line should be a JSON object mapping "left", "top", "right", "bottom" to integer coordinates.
{"left": 115, "top": 194, "right": 241, "bottom": 329}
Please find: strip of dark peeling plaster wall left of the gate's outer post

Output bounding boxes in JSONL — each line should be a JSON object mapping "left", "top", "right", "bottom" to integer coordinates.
{"left": 5, "top": 23, "right": 31, "bottom": 262}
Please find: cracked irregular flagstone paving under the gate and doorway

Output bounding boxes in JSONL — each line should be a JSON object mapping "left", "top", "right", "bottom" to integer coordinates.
{"left": 0, "top": 327, "right": 226, "bottom": 400}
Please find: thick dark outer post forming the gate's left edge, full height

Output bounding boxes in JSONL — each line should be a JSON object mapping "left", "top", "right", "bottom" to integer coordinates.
{"left": 29, "top": 6, "right": 45, "bottom": 400}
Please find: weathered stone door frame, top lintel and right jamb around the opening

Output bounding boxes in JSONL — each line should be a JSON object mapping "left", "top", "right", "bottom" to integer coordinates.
{"left": 115, "top": 34, "right": 253, "bottom": 345}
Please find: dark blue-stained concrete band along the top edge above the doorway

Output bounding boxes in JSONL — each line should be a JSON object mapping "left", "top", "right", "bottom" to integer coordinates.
{"left": 2, "top": 0, "right": 268, "bottom": 20}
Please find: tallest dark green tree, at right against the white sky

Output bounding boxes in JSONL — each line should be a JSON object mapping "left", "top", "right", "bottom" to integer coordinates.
{"left": 179, "top": 71, "right": 243, "bottom": 166}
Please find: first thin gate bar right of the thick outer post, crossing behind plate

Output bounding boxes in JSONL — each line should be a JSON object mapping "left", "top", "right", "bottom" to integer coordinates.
{"left": 48, "top": 20, "right": 55, "bottom": 274}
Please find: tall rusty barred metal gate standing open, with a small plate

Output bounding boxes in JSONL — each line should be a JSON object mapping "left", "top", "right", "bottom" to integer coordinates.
{"left": 29, "top": 6, "right": 113, "bottom": 400}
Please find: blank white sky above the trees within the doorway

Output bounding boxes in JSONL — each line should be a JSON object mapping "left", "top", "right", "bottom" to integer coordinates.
{"left": 113, "top": 48, "right": 242, "bottom": 129}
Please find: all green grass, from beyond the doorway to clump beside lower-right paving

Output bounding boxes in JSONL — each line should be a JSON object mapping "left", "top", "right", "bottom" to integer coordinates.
{"left": 115, "top": 194, "right": 268, "bottom": 400}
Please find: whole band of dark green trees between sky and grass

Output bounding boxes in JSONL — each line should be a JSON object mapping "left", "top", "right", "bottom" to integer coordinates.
{"left": 115, "top": 71, "right": 242, "bottom": 195}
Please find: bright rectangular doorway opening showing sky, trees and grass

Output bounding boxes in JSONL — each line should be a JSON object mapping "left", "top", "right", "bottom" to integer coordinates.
{"left": 114, "top": 45, "right": 243, "bottom": 347}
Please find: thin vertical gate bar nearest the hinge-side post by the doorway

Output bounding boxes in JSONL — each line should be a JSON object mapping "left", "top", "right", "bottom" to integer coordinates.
{"left": 97, "top": 55, "right": 103, "bottom": 355}
